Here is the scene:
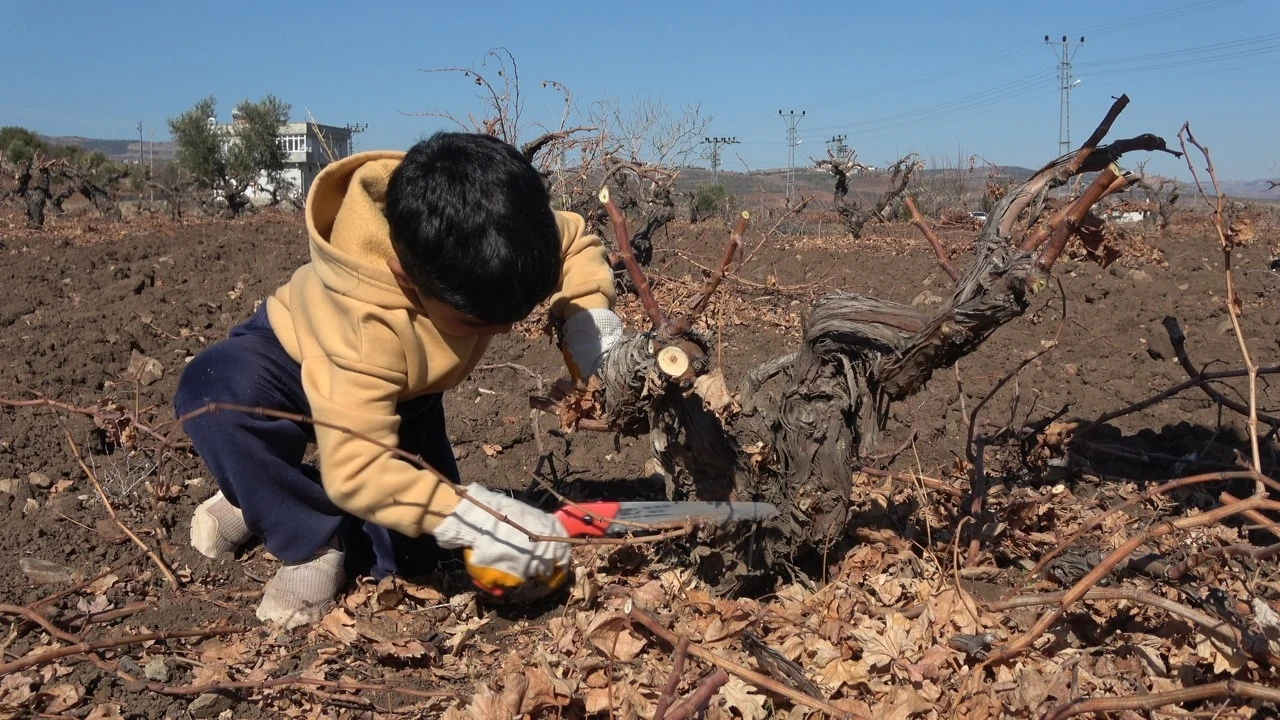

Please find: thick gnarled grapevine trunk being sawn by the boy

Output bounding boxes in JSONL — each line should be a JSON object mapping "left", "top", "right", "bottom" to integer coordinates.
{"left": 586, "top": 97, "right": 1182, "bottom": 584}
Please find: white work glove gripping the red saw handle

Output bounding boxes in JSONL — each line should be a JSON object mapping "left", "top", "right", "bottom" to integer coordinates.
{"left": 433, "top": 483, "right": 571, "bottom": 598}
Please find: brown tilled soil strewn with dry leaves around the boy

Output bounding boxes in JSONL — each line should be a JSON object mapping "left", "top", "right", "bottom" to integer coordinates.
{"left": 0, "top": 203, "right": 1280, "bottom": 719}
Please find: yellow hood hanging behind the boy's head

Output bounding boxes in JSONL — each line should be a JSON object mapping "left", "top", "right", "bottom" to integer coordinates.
{"left": 306, "top": 151, "right": 412, "bottom": 309}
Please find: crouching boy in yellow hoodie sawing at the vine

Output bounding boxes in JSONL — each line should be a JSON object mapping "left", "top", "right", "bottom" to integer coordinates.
{"left": 174, "top": 133, "right": 622, "bottom": 628}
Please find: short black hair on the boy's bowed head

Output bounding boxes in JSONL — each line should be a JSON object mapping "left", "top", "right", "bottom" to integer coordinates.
{"left": 387, "top": 132, "right": 561, "bottom": 324}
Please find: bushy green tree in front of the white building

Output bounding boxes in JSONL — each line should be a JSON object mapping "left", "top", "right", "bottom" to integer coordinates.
{"left": 169, "top": 95, "right": 289, "bottom": 217}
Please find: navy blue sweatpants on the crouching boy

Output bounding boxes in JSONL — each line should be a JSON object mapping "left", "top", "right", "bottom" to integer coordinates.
{"left": 173, "top": 304, "right": 458, "bottom": 578}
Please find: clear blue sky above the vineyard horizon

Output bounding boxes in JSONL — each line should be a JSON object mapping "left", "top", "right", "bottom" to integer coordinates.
{"left": 0, "top": 0, "right": 1280, "bottom": 179}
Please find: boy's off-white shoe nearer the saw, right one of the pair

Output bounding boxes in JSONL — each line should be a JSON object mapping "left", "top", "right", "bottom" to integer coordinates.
{"left": 257, "top": 547, "right": 347, "bottom": 630}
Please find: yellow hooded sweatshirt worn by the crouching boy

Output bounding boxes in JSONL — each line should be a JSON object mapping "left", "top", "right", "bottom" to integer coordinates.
{"left": 266, "top": 152, "right": 613, "bottom": 537}
